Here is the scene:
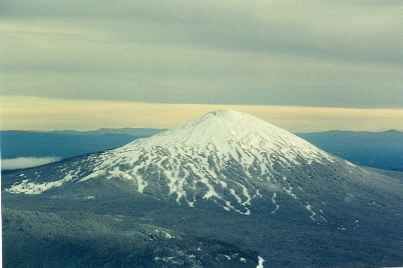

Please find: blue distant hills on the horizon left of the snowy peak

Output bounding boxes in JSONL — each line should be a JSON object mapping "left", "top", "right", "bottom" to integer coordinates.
{"left": 1, "top": 128, "right": 162, "bottom": 159}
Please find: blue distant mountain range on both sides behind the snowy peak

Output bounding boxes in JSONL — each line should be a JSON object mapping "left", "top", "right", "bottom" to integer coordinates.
{"left": 0, "top": 125, "right": 403, "bottom": 170}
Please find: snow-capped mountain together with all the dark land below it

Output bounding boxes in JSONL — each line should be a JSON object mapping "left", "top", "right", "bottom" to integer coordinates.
{"left": 2, "top": 110, "right": 403, "bottom": 268}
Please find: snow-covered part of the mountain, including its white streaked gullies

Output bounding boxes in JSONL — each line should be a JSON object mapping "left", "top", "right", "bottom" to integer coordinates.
{"left": 7, "top": 110, "right": 376, "bottom": 220}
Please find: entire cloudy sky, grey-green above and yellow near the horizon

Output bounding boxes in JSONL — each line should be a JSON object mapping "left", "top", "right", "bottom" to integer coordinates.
{"left": 0, "top": 0, "right": 403, "bottom": 132}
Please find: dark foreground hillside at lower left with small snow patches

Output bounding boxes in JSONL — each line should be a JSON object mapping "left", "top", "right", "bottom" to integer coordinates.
{"left": 3, "top": 208, "right": 258, "bottom": 267}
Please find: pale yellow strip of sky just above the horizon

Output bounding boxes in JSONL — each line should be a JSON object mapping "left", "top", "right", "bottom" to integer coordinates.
{"left": 0, "top": 96, "right": 403, "bottom": 132}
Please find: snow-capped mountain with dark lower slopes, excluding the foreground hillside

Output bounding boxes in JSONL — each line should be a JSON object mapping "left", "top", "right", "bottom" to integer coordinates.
{"left": 2, "top": 110, "right": 403, "bottom": 267}
